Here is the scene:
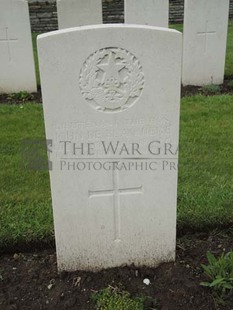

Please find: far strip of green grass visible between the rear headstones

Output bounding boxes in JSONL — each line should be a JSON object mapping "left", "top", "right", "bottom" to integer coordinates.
{"left": 32, "top": 21, "right": 233, "bottom": 86}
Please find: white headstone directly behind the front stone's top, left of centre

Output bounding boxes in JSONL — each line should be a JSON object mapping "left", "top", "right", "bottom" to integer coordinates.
{"left": 57, "top": 0, "right": 103, "bottom": 29}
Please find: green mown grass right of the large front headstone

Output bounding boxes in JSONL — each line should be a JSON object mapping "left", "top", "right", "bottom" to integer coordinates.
{"left": 178, "top": 95, "right": 233, "bottom": 229}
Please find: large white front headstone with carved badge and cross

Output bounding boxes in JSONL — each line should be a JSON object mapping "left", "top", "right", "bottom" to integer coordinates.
{"left": 38, "top": 25, "right": 182, "bottom": 270}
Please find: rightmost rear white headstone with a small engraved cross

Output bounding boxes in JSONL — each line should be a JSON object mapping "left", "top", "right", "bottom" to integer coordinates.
{"left": 182, "top": 0, "right": 229, "bottom": 86}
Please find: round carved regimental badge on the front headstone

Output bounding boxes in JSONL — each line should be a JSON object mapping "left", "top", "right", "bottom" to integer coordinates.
{"left": 79, "top": 48, "right": 144, "bottom": 112}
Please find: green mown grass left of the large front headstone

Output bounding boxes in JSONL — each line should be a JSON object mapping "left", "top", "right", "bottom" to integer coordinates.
{"left": 0, "top": 104, "right": 53, "bottom": 246}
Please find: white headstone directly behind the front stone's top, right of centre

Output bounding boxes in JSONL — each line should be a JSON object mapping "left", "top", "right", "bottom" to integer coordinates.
{"left": 125, "top": 0, "right": 169, "bottom": 28}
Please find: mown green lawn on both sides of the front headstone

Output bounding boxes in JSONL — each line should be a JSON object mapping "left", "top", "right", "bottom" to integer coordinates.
{"left": 0, "top": 95, "right": 233, "bottom": 247}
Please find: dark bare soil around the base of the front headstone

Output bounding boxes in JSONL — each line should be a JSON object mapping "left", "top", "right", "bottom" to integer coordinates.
{"left": 0, "top": 232, "right": 233, "bottom": 310}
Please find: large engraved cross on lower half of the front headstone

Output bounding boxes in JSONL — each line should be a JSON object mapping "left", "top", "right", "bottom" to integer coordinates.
{"left": 88, "top": 170, "right": 143, "bottom": 242}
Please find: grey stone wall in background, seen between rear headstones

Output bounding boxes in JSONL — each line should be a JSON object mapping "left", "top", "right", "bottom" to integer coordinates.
{"left": 28, "top": 0, "right": 233, "bottom": 32}
